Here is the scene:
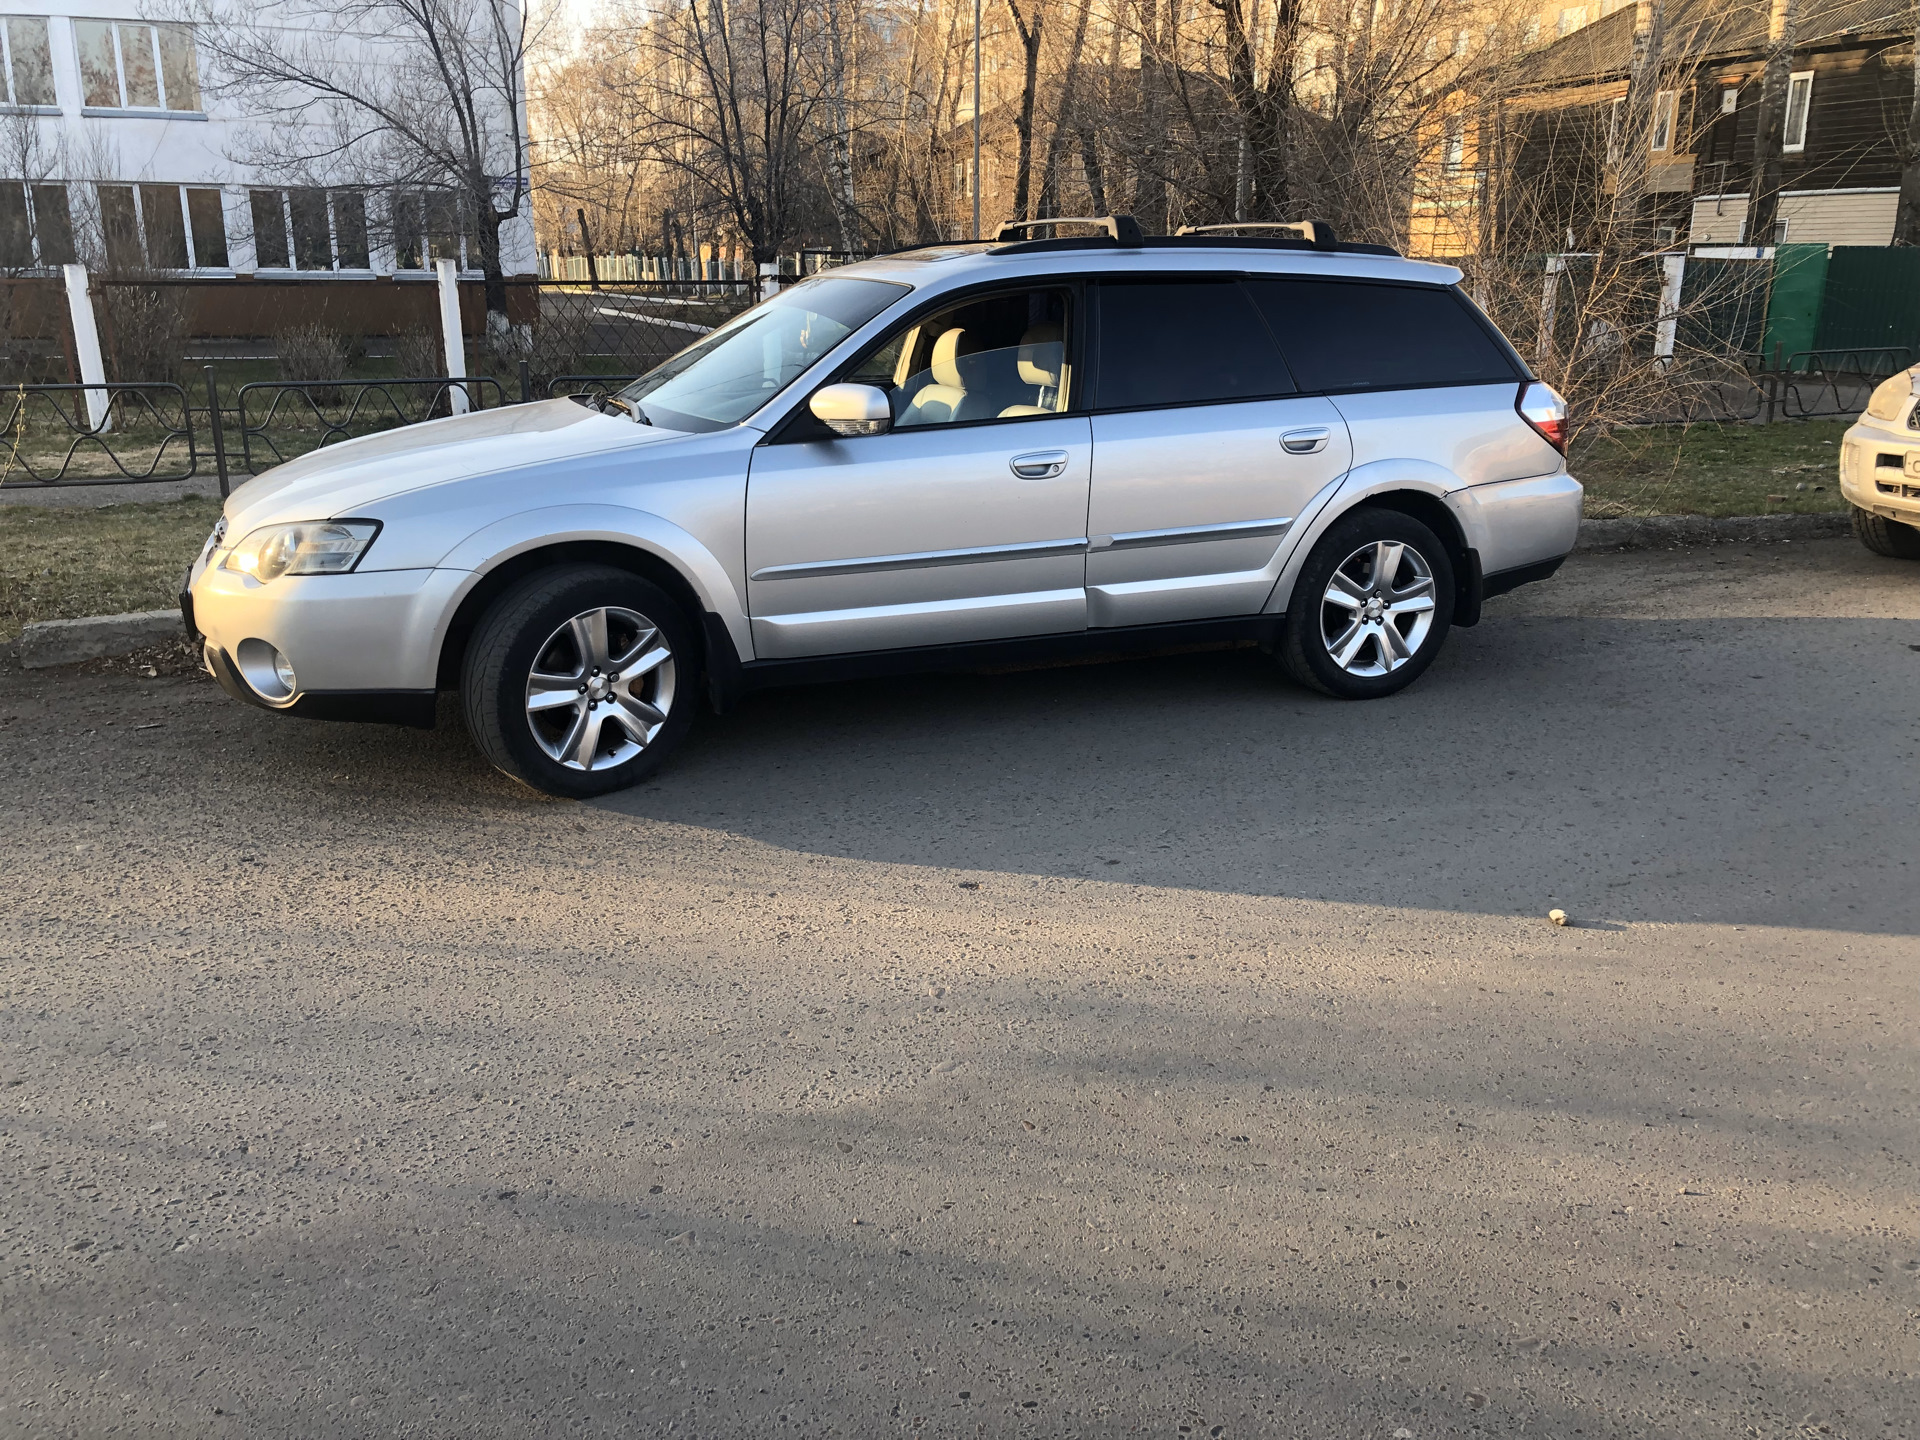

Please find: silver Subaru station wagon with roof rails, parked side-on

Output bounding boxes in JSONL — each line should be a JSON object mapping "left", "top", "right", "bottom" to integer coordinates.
{"left": 182, "top": 217, "right": 1580, "bottom": 797}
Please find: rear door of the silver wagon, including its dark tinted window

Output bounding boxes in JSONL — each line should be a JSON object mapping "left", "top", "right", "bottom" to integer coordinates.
{"left": 1087, "top": 276, "right": 1352, "bottom": 626}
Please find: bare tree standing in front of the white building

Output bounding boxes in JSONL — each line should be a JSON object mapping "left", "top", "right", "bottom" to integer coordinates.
{"left": 190, "top": 0, "right": 532, "bottom": 353}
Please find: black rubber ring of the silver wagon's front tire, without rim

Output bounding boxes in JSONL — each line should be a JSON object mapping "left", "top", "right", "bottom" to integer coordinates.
{"left": 476, "top": 566, "right": 699, "bottom": 799}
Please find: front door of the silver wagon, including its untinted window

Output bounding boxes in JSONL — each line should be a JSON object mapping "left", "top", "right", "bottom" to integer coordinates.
{"left": 747, "top": 288, "right": 1092, "bottom": 659}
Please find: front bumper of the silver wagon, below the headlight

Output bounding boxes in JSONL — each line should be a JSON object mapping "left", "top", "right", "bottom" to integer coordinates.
{"left": 180, "top": 564, "right": 472, "bottom": 726}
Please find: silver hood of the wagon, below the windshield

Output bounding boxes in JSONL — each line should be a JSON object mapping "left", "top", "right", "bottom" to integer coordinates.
{"left": 227, "top": 399, "right": 685, "bottom": 534}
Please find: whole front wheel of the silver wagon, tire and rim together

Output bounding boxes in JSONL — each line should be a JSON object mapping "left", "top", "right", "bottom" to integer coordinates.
{"left": 461, "top": 564, "right": 701, "bottom": 799}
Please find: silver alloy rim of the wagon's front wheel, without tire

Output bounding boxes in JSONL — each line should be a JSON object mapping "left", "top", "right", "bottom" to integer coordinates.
{"left": 526, "top": 605, "right": 674, "bottom": 770}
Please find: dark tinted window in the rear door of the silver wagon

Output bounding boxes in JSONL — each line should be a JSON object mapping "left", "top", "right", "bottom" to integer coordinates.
{"left": 1094, "top": 280, "right": 1294, "bottom": 411}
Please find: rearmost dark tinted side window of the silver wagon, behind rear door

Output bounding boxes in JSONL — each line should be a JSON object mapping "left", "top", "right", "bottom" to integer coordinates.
{"left": 1246, "top": 280, "right": 1519, "bottom": 392}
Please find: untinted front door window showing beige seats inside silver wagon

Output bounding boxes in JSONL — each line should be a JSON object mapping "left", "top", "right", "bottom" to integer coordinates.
{"left": 879, "top": 288, "right": 1071, "bottom": 430}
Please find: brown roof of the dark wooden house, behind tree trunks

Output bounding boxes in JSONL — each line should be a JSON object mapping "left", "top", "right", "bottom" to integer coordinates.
{"left": 1521, "top": 0, "right": 1914, "bottom": 86}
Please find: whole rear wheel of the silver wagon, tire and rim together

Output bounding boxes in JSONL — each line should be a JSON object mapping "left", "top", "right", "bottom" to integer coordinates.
{"left": 1281, "top": 505, "right": 1453, "bottom": 701}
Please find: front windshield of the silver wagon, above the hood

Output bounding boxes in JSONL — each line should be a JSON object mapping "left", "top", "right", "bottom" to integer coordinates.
{"left": 620, "top": 275, "right": 908, "bottom": 430}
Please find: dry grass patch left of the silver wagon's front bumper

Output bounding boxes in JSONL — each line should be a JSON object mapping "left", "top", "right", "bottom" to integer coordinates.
{"left": 0, "top": 495, "right": 221, "bottom": 641}
